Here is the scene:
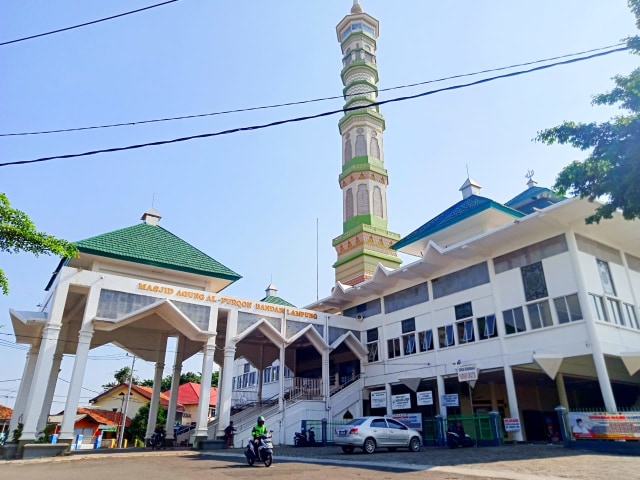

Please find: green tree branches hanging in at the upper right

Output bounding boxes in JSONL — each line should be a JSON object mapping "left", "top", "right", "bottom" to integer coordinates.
{"left": 536, "top": 0, "right": 640, "bottom": 224}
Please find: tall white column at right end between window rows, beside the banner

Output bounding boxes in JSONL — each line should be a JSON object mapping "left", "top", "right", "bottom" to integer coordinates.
{"left": 566, "top": 232, "right": 618, "bottom": 412}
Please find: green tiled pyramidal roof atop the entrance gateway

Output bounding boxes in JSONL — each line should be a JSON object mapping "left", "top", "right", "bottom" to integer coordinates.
{"left": 75, "top": 223, "right": 242, "bottom": 282}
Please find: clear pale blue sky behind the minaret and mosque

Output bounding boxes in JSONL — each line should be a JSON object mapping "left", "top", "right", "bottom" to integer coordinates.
{"left": 0, "top": 0, "right": 638, "bottom": 410}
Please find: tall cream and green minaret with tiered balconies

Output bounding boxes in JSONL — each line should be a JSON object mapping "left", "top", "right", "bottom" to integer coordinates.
{"left": 333, "top": 0, "right": 402, "bottom": 285}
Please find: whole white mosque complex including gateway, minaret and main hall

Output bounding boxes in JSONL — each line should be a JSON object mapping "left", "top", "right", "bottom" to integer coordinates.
{"left": 10, "top": 0, "right": 640, "bottom": 450}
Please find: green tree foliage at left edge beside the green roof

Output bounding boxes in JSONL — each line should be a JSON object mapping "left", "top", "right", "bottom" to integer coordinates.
{"left": 0, "top": 193, "right": 78, "bottom": 295}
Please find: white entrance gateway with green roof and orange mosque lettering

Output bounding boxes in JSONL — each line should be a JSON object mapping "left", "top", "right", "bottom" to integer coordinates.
{"left": 10, "top": 208, "right": 366, "bottom": 450}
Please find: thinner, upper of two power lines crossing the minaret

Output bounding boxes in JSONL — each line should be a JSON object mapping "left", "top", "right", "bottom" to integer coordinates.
{"left": 0, "top": 42, "right": 625, "bottom": 137}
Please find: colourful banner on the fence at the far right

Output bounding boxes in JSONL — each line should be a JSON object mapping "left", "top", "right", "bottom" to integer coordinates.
{"left": 569, "top": 412, "right": 640, "bottom": 440}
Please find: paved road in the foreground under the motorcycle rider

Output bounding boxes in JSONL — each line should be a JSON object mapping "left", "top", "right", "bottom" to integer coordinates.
{"left": 0, "top": 445, "right": 640, "bottom": 480}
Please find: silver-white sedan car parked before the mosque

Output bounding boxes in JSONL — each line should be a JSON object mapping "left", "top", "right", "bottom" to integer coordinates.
{"left": 333, "top": 417, "right": 422, "bottom": 453}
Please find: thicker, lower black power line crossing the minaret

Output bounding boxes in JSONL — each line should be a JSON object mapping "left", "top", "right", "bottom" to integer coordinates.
{"left": 0, "top": 47, "right": 629, "bottom": 167}
